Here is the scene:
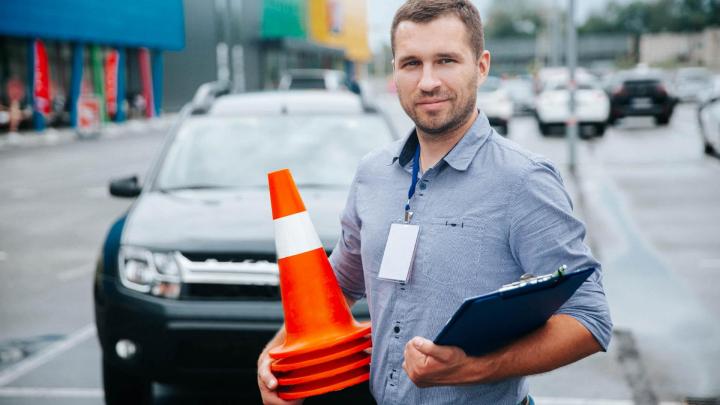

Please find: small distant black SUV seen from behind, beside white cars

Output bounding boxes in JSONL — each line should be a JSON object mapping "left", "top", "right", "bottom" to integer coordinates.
{"left": 609, "top": 72, "right": 677, "bottom": 125}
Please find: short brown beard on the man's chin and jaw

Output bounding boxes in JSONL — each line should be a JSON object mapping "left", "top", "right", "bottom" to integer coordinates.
{"left": 400, "top": 84, "right": 477, "bottom": 138}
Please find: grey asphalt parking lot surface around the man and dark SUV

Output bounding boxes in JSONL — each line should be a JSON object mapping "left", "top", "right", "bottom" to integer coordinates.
{"left": 0, "top": 96, "right": 720, "bottom": 405}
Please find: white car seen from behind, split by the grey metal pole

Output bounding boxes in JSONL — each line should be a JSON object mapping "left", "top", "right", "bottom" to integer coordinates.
{"left": 535, "top": 80, "right": 610, "bottom": 137}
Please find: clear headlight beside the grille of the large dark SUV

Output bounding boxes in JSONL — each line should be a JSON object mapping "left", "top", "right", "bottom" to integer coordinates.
{"left": 118, "top": 246, "right": 180, "bottom": 298}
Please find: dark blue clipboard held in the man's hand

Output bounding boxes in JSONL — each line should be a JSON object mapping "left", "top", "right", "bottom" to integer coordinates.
{"left": 434, "top": 268, "right": 595, "bottom": 356}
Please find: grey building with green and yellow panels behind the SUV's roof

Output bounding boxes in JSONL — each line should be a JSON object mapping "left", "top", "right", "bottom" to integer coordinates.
{"left": 164, "top": 0, "right": 371, "bottom": 110}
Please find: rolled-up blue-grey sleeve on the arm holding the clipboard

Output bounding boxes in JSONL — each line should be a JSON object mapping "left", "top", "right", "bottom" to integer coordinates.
{"left": 508, "top": 161, "right": 612, "bottom": 351}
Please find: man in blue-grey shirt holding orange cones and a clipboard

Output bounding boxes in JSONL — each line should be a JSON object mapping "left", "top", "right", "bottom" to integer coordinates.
{"left": 258, "top": 0, "right": 612, "bottom": 404}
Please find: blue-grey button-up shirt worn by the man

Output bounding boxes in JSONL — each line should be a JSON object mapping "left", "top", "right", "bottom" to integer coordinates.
{"left": 330, "top": 113, "right": 612, "bottom": 404}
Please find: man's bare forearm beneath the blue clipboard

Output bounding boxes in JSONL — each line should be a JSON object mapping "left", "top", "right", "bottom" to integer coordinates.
{"left": 466, "top": 315, "right": 601, "bottom": 383}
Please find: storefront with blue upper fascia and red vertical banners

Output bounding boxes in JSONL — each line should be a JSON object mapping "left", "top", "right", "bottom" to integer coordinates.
{"left": 0, "top": 0, "right": 185, "bottom": 129}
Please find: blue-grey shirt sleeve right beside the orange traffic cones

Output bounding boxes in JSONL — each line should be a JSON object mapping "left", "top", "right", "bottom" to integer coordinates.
{"left": 330, "top": 175, "right": 365, "bottom": 301}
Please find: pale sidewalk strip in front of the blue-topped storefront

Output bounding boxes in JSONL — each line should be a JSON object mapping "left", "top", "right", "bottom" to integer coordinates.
{"left": 0, "top": 113, "right": 177, "bottom": 151}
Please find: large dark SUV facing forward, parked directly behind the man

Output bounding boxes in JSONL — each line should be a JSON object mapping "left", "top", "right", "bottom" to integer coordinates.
{"left": 94, "top": 86, "right": 396, "bottom": 404}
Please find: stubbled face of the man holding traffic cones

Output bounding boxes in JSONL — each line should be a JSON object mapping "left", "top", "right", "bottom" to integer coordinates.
{"left": 393, "top": 15, "right": 490, "bottom": 136}
